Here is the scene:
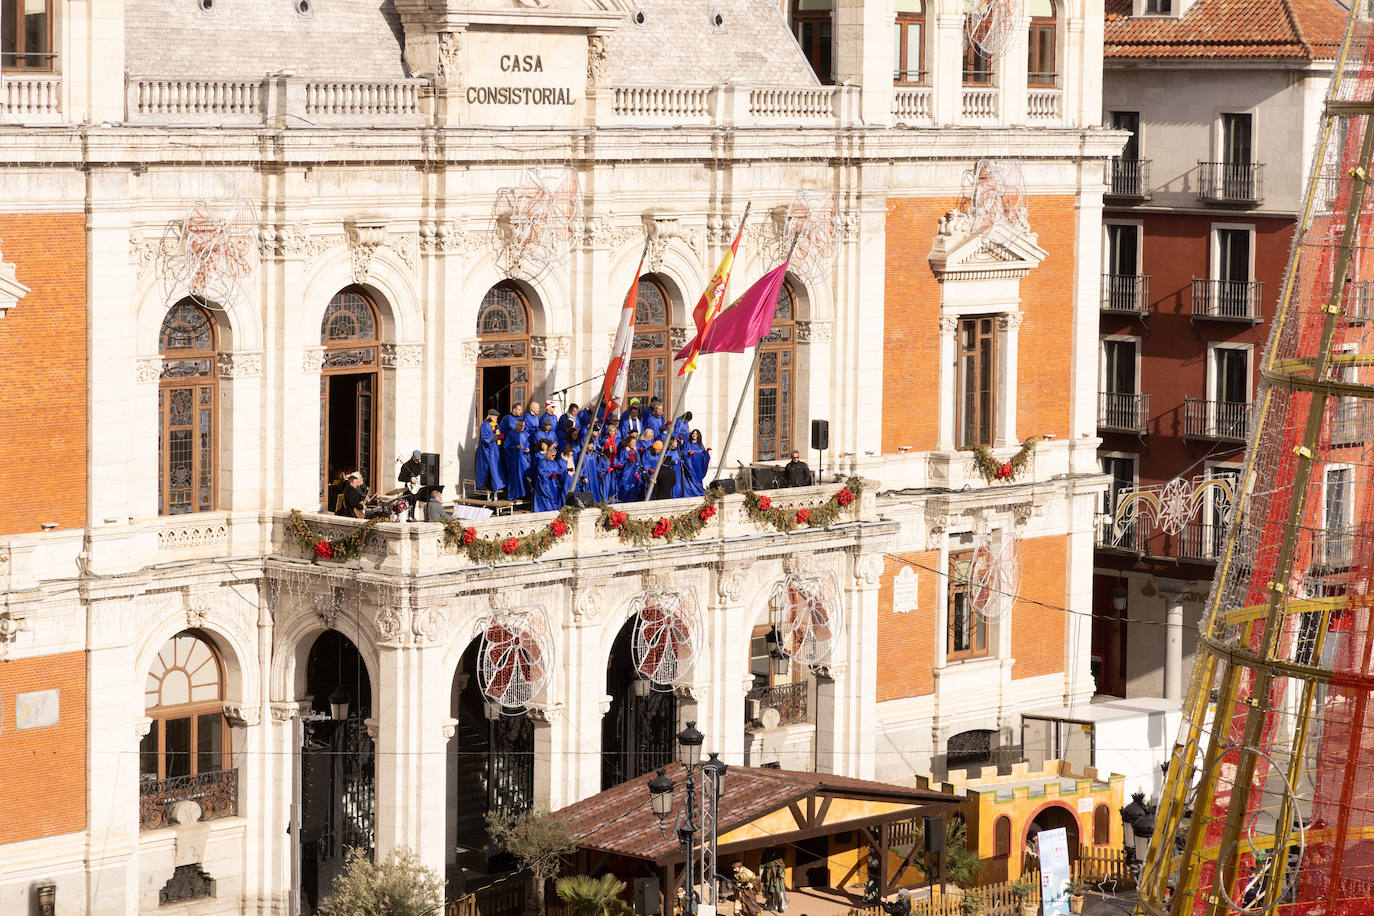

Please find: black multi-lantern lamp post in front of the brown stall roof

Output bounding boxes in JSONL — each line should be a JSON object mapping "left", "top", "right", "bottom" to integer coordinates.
{"left": 649, "top": 721, "right": 730, "bottom": 916}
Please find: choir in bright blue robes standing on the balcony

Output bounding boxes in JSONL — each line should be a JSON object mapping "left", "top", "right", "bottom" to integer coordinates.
{"left": 474, "top": 397, "right": 710, "bottom": 512}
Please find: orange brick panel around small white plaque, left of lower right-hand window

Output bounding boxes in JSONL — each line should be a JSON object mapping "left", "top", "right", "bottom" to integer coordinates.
{"left": 878, "top": 551, "right": 940, "bottom": 703}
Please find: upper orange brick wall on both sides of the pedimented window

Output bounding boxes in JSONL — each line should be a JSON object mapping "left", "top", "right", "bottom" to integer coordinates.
{"left": 882, "top": 195, "right": 1077, "bottom": 453}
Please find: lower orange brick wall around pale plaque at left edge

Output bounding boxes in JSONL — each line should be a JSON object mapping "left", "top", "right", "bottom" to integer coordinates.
{"left": 0, "top": 650, "right": 87, "bottom": 846}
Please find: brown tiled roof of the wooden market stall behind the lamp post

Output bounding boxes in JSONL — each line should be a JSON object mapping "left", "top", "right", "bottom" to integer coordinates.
{"left": 556, "top": 764, "right": 963, "bottom": 862}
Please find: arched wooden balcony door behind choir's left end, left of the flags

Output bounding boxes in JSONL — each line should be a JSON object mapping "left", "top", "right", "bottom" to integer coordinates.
{"left": 473, "top": 280, "right": 530, "bottom": 424}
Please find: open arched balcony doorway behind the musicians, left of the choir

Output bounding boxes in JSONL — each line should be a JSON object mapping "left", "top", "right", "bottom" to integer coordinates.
{"left": 320, "top": 286, "right": 382, "bottom": 509}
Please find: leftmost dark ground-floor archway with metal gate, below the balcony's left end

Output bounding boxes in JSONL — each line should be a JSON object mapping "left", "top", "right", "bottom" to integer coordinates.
{"left": 300, "top": 630, "right": 376, "bottom": 913}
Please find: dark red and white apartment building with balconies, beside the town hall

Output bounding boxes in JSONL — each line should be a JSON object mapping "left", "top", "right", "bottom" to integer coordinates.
{"left": 1092, "top": 0, "right": 1358, "bottom": 699}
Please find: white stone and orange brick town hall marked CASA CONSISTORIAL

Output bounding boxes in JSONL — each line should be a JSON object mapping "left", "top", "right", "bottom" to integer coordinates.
{"left": 0, "top": 0, "right": 1124, "bottom": 913}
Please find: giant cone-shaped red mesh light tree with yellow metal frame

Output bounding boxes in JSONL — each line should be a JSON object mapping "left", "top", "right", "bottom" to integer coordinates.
{"left": 1138, "top": 3, "right": 1374, "bottom": 916}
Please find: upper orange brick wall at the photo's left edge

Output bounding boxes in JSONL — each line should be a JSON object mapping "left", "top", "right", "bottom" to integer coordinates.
{"left": 0, "top": 213, "right": 87, "bottom": 536}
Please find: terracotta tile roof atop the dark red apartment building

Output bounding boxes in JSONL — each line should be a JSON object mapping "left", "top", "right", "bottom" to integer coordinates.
{"left": 1103, "top": 0, "right": 1348, "bottom": 60}
